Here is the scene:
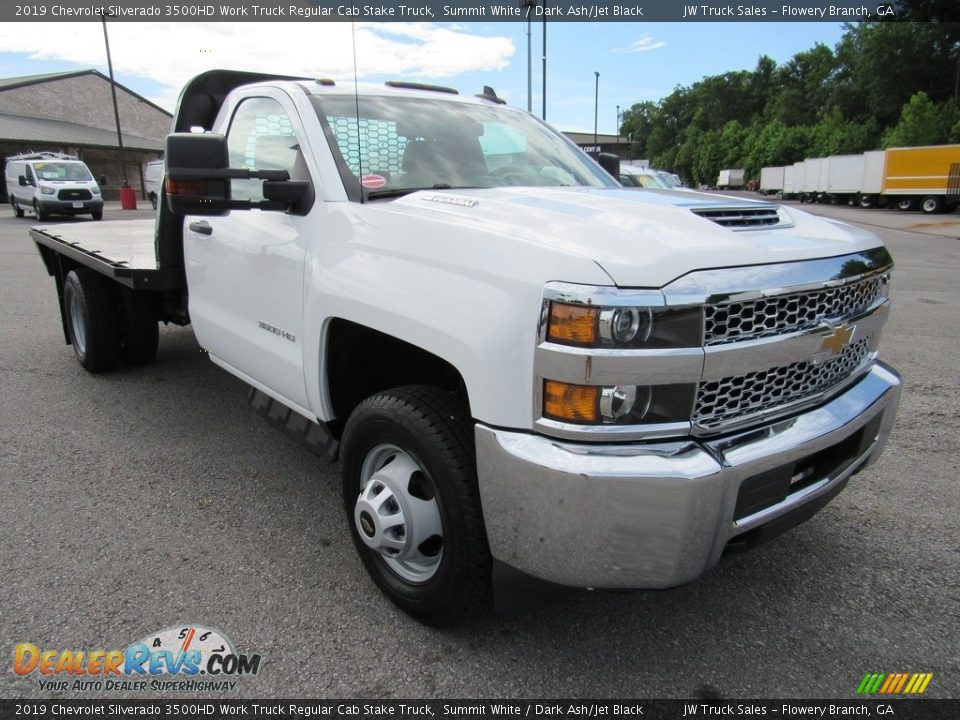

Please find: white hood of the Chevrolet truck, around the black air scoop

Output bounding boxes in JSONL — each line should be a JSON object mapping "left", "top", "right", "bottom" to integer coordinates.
{"left": 378, "top": 187, "right": 882, "bottom": 287}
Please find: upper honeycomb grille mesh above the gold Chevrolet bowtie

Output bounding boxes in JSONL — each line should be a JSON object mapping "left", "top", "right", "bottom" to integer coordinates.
{"left": 704, "top": 276, "right": 885, "bottom": 345}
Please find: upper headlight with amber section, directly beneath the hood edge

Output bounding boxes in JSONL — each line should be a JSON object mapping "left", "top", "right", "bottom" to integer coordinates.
{"left": 546, "top": 300, "right": 703, "bottom": 350}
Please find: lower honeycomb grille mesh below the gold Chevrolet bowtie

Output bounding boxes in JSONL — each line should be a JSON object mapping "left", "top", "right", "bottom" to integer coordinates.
{"left": 693, "top": 337, "right": 870, "bottom": 429}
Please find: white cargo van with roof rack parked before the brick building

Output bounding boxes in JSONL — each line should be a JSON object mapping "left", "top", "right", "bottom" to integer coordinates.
{"left": 5, "top": 152, "right": 103, "bottom": 222}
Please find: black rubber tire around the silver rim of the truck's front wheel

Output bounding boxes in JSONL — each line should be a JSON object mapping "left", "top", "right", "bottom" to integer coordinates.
{"left": 342, "top": 385, "right": 491, "bottom": 627}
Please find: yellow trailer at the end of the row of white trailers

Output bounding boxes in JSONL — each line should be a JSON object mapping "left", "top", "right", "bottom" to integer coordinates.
{"left": 881, "top": 145, "right": 960, "bottom": 213}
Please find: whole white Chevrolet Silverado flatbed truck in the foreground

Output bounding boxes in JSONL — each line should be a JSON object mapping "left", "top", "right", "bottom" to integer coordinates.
{"left": 31, "top": 71, "right": 900, "bottom": 625}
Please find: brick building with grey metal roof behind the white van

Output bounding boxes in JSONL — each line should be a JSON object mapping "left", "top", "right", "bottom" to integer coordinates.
{"left": 0, "top": 70, "right": 172, "bottom": 203}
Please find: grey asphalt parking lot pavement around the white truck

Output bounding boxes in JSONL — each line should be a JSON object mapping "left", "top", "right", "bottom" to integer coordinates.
{"left": 0, "top": 201, "right": 960, "bottom": 698}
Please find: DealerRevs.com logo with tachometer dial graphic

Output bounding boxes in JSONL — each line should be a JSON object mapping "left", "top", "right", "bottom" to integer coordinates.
{"left": 13, "top": 624, "right": 260, "bottom": 692}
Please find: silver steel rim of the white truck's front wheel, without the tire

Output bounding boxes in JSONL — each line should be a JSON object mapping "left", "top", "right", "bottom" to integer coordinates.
{"left": 353, "top": 444, "right": 443, "bottom": 583}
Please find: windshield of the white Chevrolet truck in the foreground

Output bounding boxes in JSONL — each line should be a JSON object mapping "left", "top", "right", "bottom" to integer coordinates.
{"left": 312, "top": 95, "right": 616, "bottom": 199}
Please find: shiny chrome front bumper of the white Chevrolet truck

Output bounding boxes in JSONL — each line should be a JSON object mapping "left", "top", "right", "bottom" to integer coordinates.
{"left": 476, "top": 363, "right": 900, "bottom": 588}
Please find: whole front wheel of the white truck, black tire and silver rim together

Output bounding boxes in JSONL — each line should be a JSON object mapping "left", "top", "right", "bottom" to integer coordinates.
{"left": 343, "top": 385, "right": 491, "bottom": 627}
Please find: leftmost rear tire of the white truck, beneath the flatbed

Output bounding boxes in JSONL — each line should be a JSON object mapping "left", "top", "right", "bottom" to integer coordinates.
{"left": 63, "top": 268, "right": 120, "bottom": 373}
